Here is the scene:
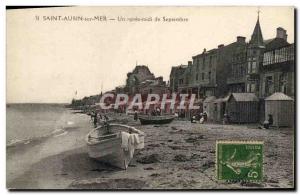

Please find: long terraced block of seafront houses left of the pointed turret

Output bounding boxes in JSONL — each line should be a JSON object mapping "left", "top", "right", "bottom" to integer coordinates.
{"left": 170, "top": 36, "right": 247, "bottom": 99}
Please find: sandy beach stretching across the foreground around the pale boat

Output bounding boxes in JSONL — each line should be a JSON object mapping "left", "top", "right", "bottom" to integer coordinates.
{"left": 7, "top": 112, "right": 294, "bottom": 189}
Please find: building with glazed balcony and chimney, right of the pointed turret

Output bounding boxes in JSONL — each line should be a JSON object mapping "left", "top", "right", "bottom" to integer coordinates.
{"left": 259, "top": 31, "right": 295, "bottom": 98}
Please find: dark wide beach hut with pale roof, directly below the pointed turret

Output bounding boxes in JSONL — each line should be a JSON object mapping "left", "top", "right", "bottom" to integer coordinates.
{"left": 226, "top": 93, "right": 259, "bottom": 123}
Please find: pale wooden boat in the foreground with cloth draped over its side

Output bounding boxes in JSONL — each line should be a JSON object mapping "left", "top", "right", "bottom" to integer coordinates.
{"left": 86, "top": 124, "right": 145, "bottom": 169}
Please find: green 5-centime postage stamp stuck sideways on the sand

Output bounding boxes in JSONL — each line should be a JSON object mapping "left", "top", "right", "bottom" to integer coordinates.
{"left": 216, "top": 141, "right": 264, "bottom": 182}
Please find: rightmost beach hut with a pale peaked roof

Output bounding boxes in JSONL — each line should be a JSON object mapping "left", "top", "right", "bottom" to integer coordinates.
{"left": 265, "top": 92, "right": 294, "bottom": 127}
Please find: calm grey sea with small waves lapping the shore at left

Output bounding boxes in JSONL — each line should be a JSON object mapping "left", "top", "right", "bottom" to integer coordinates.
{"left": 6, "top": 104, "right": 88, "bottom": 146}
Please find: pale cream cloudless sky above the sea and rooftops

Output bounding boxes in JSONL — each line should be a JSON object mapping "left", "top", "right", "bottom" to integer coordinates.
{"left": 6, "top": 7, "right": 294, "bottom": 103}
